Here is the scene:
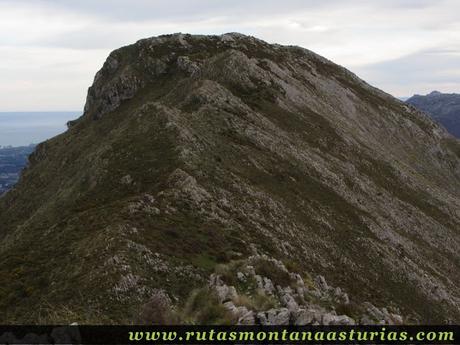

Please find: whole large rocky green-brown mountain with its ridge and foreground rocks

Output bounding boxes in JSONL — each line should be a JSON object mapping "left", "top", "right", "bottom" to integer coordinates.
{"left": 0, "top": 33, "right": 460, "bottom": 324}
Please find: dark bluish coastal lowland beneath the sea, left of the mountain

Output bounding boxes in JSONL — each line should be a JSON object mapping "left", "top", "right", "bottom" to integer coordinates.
{"left": 0, "top": 145, "right": 35, "bottom": 195}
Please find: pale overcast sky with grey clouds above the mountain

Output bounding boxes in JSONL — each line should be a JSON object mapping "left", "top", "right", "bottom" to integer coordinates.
{"left": 0, "top": 0, "right": 460, "bottom": 111}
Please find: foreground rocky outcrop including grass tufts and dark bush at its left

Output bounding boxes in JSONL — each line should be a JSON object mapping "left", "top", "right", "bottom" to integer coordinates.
{"left": 139, "top": 255, "right": 404, "bottom": 326}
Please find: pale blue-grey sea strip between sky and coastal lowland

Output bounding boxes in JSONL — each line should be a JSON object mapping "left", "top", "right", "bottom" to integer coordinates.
{"left": 0, "top": 111, "right": 82, "bottom": 146}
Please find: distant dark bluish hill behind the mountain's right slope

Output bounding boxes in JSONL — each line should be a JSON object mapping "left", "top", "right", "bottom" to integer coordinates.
{"left": 406, "top": 91, "right": 460, "bottom": 138}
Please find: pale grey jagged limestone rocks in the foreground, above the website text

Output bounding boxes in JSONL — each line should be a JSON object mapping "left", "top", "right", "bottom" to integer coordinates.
{"left": 209, "top": 256, "right": 403, "bottom": 326}
